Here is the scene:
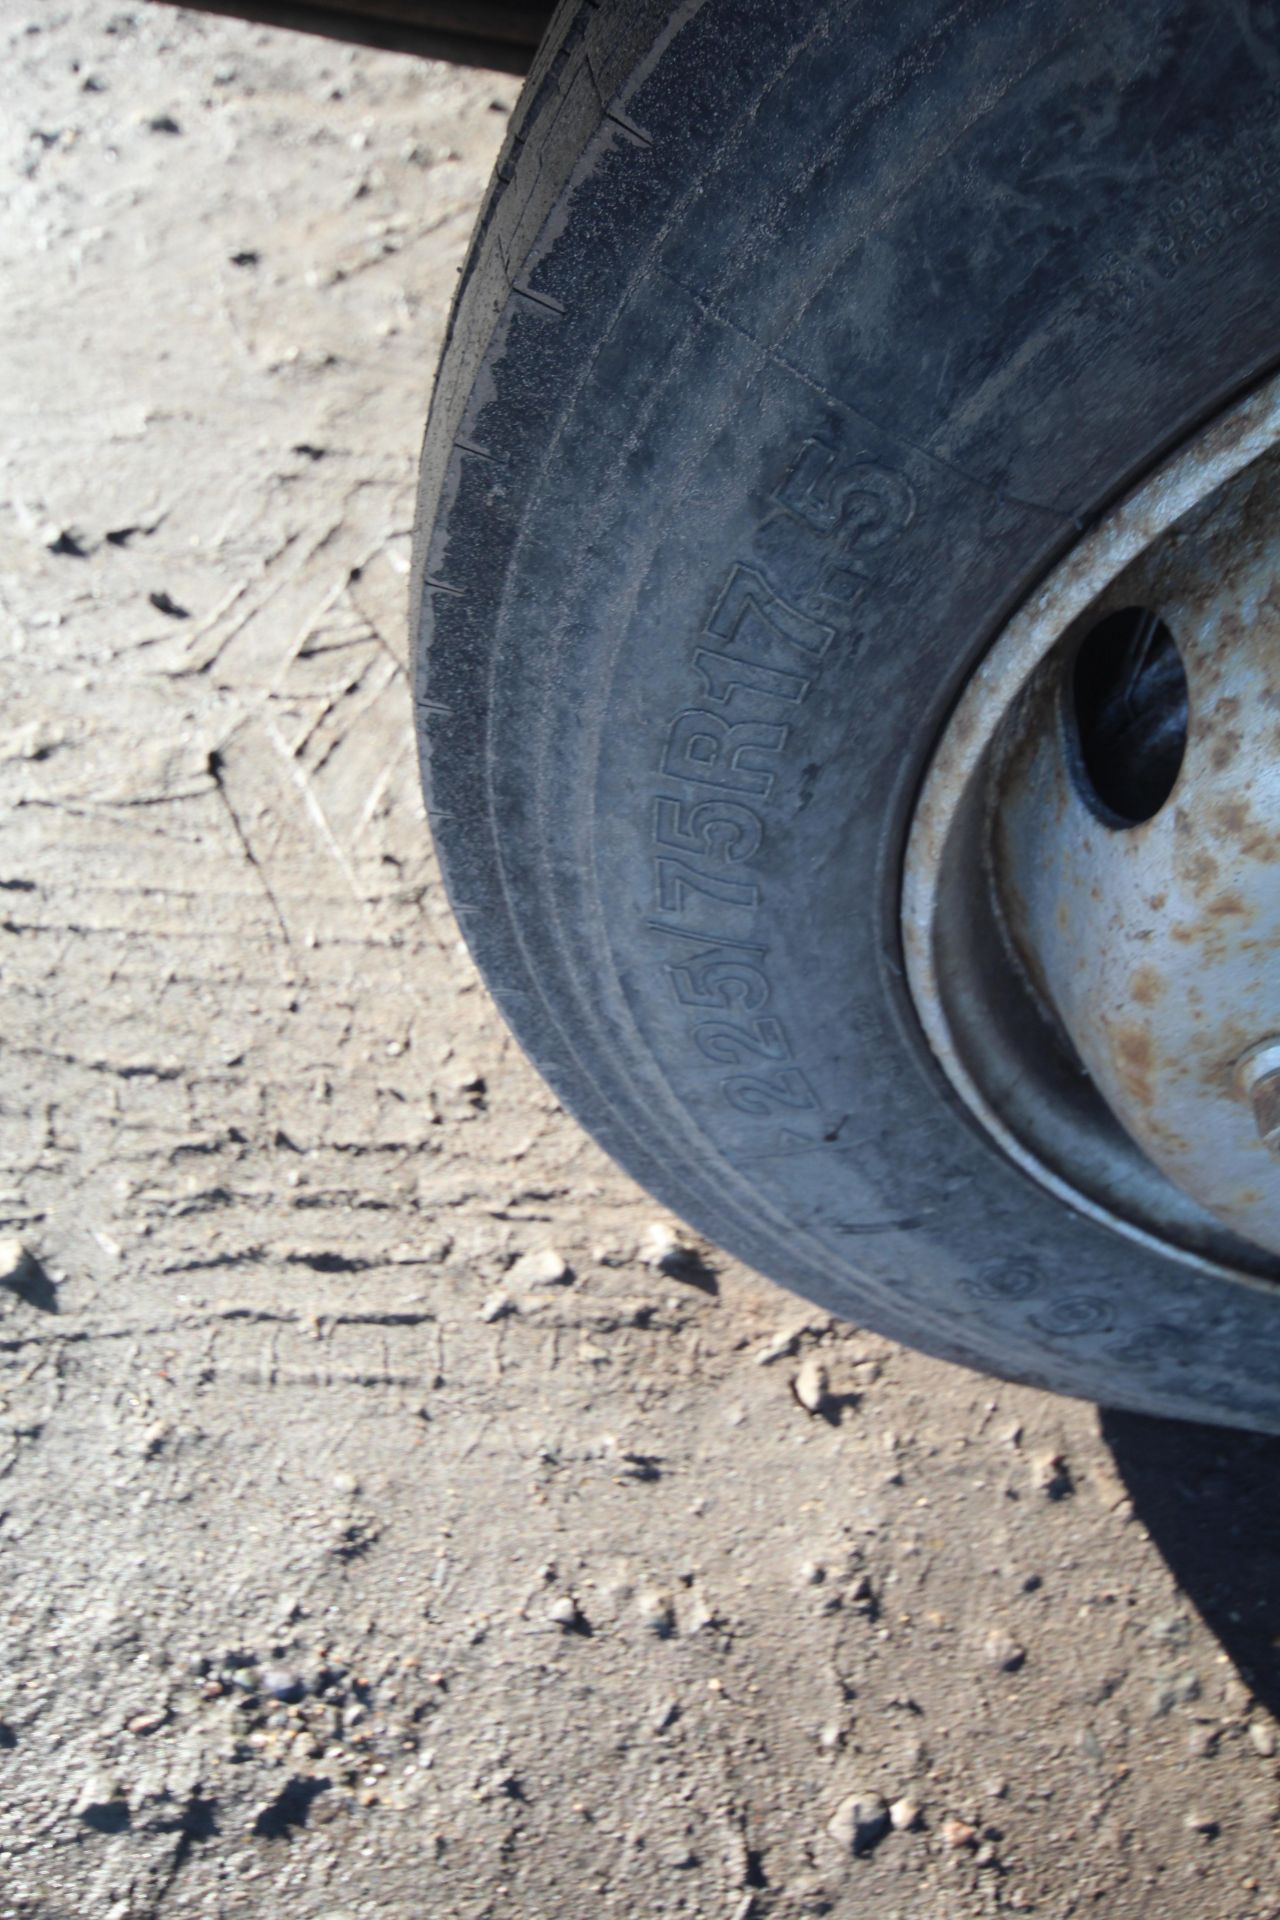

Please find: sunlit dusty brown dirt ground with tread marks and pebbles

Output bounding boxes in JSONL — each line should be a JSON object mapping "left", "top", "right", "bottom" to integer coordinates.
{"left": 0, "top": 0, "right": 1280, "bottom": 1920}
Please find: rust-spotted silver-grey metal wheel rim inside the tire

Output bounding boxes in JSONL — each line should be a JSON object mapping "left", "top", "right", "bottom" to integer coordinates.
{"left": 902, "top": 378, "right": 1280, "bottom": 1279}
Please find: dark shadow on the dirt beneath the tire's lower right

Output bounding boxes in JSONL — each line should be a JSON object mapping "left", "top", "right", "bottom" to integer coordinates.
{"left": 1102, "top": 1413, "right": 1280, "bottom": 1713}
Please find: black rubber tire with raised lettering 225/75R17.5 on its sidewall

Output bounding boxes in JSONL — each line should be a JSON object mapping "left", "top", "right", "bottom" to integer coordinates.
{"left": 415, "top": 0, "right": 1280, "bottom": 1428}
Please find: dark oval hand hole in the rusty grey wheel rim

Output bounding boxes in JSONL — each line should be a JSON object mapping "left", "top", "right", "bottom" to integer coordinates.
{"left": 1067, "top": 607, "right": 1188, "bottom": 828}
